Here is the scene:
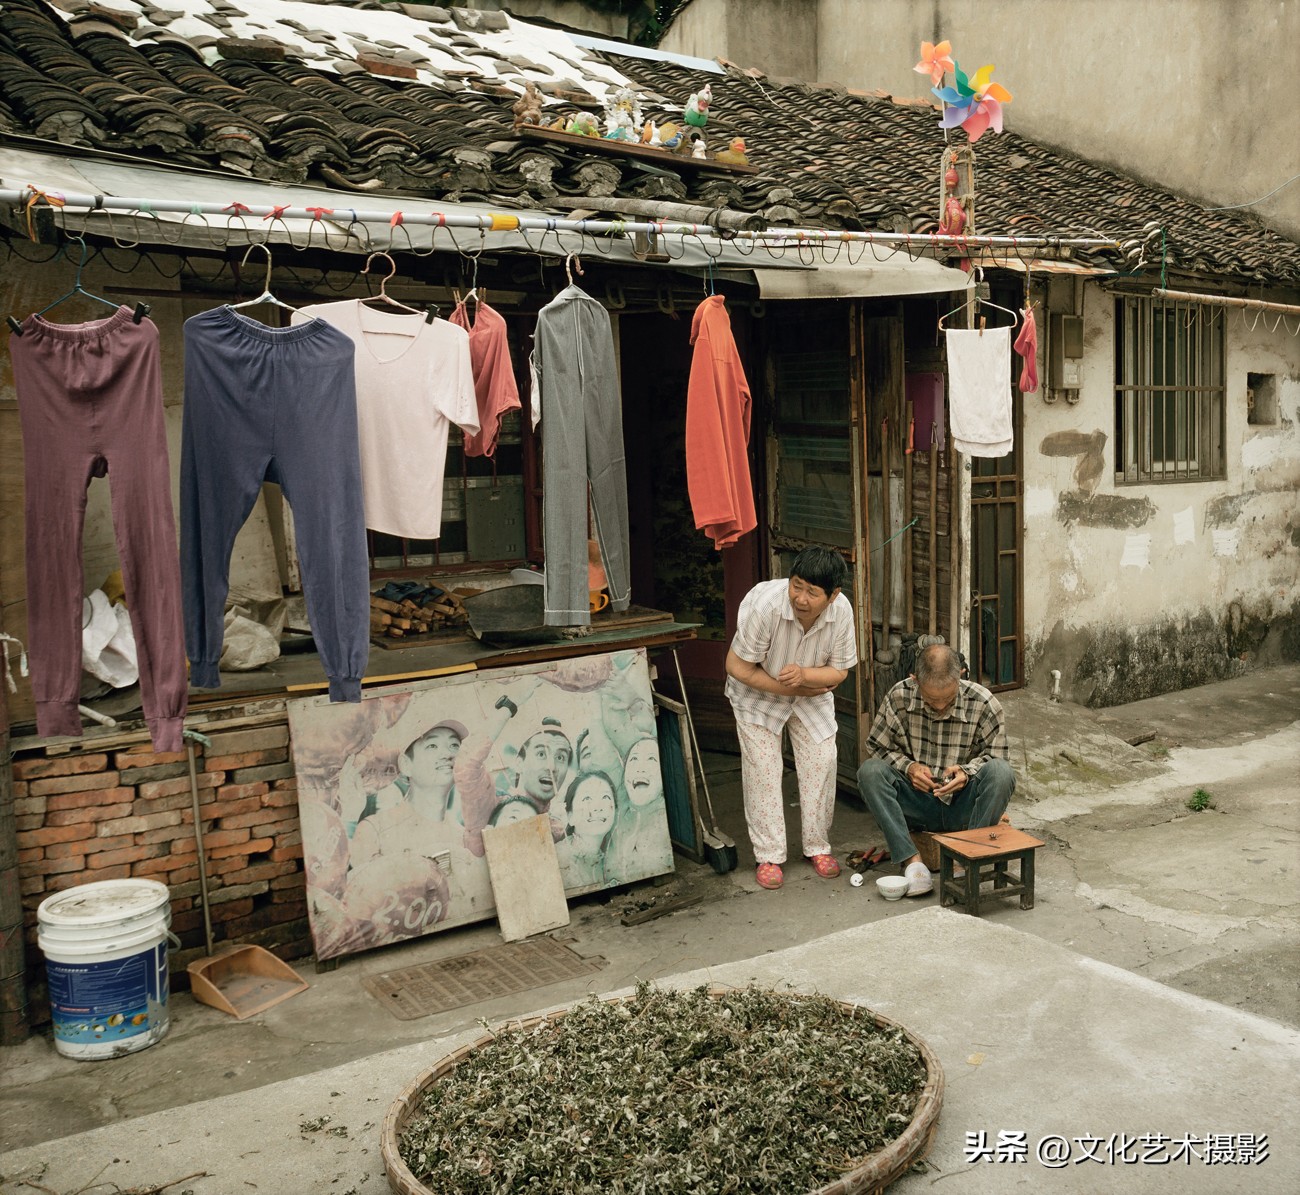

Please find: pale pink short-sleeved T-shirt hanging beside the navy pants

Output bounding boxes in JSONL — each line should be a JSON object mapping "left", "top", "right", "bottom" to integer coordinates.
{"left": 293, "top": 299, "right": 478, "bottom": 540}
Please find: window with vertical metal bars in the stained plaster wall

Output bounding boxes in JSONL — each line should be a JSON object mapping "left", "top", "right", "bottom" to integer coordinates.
{"left": 1115, "top": 295, "right": 1225, "bottom": 484}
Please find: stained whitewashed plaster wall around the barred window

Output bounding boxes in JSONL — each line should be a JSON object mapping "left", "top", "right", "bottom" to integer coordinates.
{"left": 1024, "top": 285, "right": 1300, "bottom": 706}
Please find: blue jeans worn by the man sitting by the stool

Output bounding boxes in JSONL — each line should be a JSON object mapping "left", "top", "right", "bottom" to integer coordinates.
{"left": 858, "top": 759, "right": 1015, "bottom": 863}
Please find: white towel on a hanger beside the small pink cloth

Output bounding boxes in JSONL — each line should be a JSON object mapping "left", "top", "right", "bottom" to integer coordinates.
{"left": 946, "top": 328, "right": 1014, "bottom": 456}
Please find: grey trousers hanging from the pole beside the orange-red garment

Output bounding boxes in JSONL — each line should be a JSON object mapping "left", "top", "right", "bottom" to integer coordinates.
{"left": 532, "top": 286, "right": 631, "bottom": 627}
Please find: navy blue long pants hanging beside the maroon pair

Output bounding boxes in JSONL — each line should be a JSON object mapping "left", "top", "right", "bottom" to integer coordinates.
{"left": 180, "top": 307, "right": 371, "bottom": 701}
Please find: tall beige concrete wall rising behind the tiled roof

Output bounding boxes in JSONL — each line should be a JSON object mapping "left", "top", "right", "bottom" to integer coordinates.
{"left": 663, "top": 0, "right": 1300, "bottom": 238}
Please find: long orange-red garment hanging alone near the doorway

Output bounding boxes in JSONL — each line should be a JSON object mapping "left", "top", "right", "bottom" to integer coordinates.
{"left": 686, "top": 295, "right": 758, "bottom": 549}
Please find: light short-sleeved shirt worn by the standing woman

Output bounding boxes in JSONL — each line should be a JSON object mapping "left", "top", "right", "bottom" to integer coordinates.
{"left": 727, "top": 579, "right": 858, "bottom": 742}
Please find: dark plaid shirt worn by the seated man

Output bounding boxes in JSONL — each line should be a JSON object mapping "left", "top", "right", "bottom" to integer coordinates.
{"left": 867, "top": 676, "right": 1011, "bottom": 805}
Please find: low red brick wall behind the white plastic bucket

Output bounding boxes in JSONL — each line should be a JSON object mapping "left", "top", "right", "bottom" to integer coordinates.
{"left": 13, "top": 711, "right": 312, "bottom": 1023}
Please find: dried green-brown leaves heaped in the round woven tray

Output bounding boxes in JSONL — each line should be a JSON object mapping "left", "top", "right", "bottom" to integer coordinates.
{"left": 399, "top": 984, "right": 927, "bottom": 1195}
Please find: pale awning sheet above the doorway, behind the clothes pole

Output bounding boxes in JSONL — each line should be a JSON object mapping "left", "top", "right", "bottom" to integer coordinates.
{"left": 751, "top": 249, "right": 971, "bottom": 299}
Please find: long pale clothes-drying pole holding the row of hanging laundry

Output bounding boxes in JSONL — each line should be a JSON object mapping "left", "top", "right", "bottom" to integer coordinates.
{"left": 0, "top": 185, "right": 1121, "bottom": 251}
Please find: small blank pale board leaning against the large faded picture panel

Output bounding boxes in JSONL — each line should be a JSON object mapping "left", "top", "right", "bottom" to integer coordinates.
{"left": 484, "top": 814, "right": 569, "bottom": 941}
